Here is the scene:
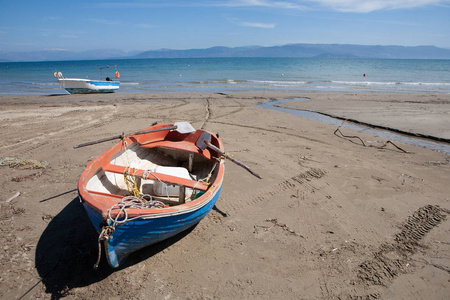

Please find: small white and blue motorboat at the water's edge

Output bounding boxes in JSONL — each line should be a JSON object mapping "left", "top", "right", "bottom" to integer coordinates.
{"left": 53, "top": 68, "right": 120, "bottom": 94}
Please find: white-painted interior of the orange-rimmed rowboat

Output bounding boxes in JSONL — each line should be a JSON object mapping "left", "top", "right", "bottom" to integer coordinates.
{"left": 87, "top": 142, "right": 220, "bottom": 205}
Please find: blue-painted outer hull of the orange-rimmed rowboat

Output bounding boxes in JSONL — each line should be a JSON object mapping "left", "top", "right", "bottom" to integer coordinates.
{"left": 83, "top": 187, "right": 221, "bottom": 268}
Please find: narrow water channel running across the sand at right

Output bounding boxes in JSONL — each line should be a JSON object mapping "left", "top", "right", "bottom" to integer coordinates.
{"left": 258, "top": 98, "right": 450, "bottom": 154}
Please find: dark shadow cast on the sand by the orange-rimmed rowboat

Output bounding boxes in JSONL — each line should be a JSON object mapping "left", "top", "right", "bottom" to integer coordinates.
{"left": 35, "top": 198, "right": 195, "bottom": 299}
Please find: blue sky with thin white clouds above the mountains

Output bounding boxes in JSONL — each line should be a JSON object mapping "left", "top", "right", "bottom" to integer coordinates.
{"left": 0, "top": 0, "right": 450, "bottom": 52}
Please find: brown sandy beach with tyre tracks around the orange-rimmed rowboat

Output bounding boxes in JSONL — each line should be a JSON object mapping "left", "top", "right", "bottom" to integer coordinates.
{"left": 0, "top": 93, "right": 450, "bottom": 299}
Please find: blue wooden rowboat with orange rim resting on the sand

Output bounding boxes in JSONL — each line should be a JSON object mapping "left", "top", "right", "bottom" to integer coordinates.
{"left": 78, "top": 122, "right": 225, "bottom": 268}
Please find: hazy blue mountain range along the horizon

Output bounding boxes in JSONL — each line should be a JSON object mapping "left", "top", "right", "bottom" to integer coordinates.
{"left": 0, "top": 44, "right": 450, "bottom": 62}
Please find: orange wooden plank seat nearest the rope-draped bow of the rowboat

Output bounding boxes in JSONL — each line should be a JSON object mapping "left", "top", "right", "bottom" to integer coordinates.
{"left": 102, "top": 164, "right": 208, "bottom": 192}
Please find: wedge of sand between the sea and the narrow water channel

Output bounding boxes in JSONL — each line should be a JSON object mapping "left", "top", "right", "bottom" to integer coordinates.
{"left": 281, "top": 94, "right": 450, "bottom": 142}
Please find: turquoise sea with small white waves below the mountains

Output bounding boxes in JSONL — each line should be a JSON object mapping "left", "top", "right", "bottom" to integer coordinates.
{"left": 0, "top": 58, "right": 450, "bottom": 95}
